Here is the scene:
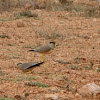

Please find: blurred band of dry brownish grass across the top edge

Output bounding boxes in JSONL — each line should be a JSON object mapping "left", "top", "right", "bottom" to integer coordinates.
{"left": 0, "top": 0, "right": 100, "bottom": 17}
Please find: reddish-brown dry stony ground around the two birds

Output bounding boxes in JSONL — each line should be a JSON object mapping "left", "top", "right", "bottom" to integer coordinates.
{"left": 0, "top": 0, "right": 100, "bottom": 100}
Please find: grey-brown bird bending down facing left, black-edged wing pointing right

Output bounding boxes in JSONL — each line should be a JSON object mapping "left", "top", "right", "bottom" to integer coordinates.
{"left": 17, "top": 62, "right": 43, "bottom": 72}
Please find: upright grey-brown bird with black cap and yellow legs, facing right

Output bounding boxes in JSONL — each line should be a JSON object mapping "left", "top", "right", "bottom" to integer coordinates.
{"left": 29, "top": 42, "right": 56, "bottom": 62}
